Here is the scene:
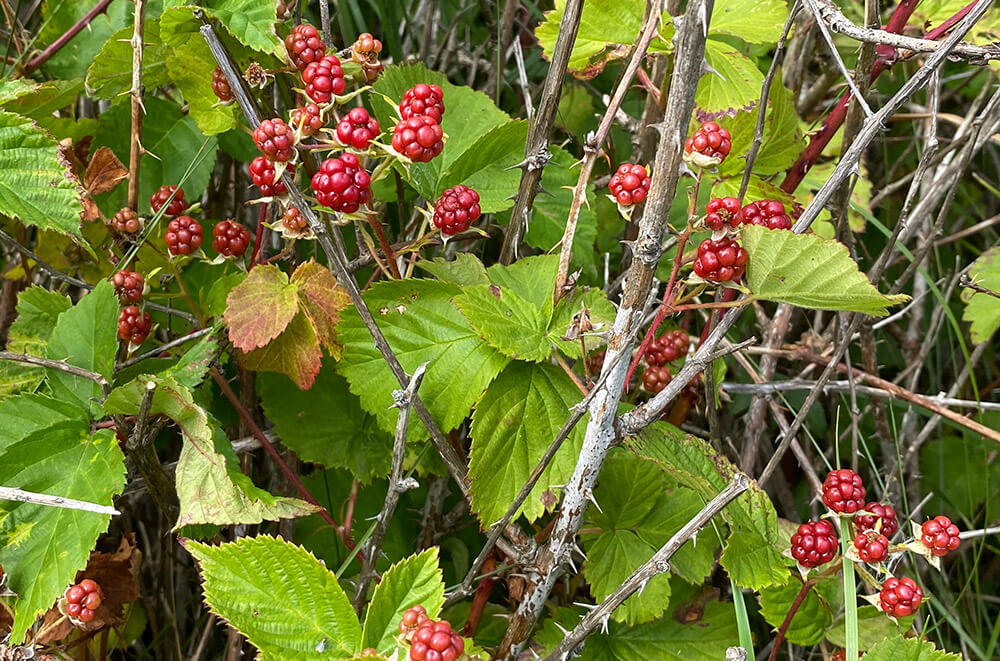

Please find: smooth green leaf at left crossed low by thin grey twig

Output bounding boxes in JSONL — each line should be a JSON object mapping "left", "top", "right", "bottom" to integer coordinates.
{"left": 45, "top": 280, "right": 118, "bottom": 415}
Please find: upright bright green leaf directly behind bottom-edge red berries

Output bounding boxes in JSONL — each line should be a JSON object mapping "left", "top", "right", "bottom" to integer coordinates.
{"left": 361, "top": 547, "right": 444, "bottom": 655}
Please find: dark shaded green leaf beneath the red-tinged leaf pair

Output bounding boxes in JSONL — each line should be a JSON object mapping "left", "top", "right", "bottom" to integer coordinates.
{"left": 257, "top": 366, "right": 392, "bottom": 483}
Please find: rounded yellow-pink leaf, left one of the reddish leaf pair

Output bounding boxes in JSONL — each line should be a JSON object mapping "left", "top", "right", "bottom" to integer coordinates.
{"left": 222, "top": 265, "right": 299, "bottom": 351}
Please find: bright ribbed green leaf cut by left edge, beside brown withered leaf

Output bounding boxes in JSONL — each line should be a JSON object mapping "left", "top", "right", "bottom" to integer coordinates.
{"left": 0, "top": 112, "right": 83, "bottom": 239}
